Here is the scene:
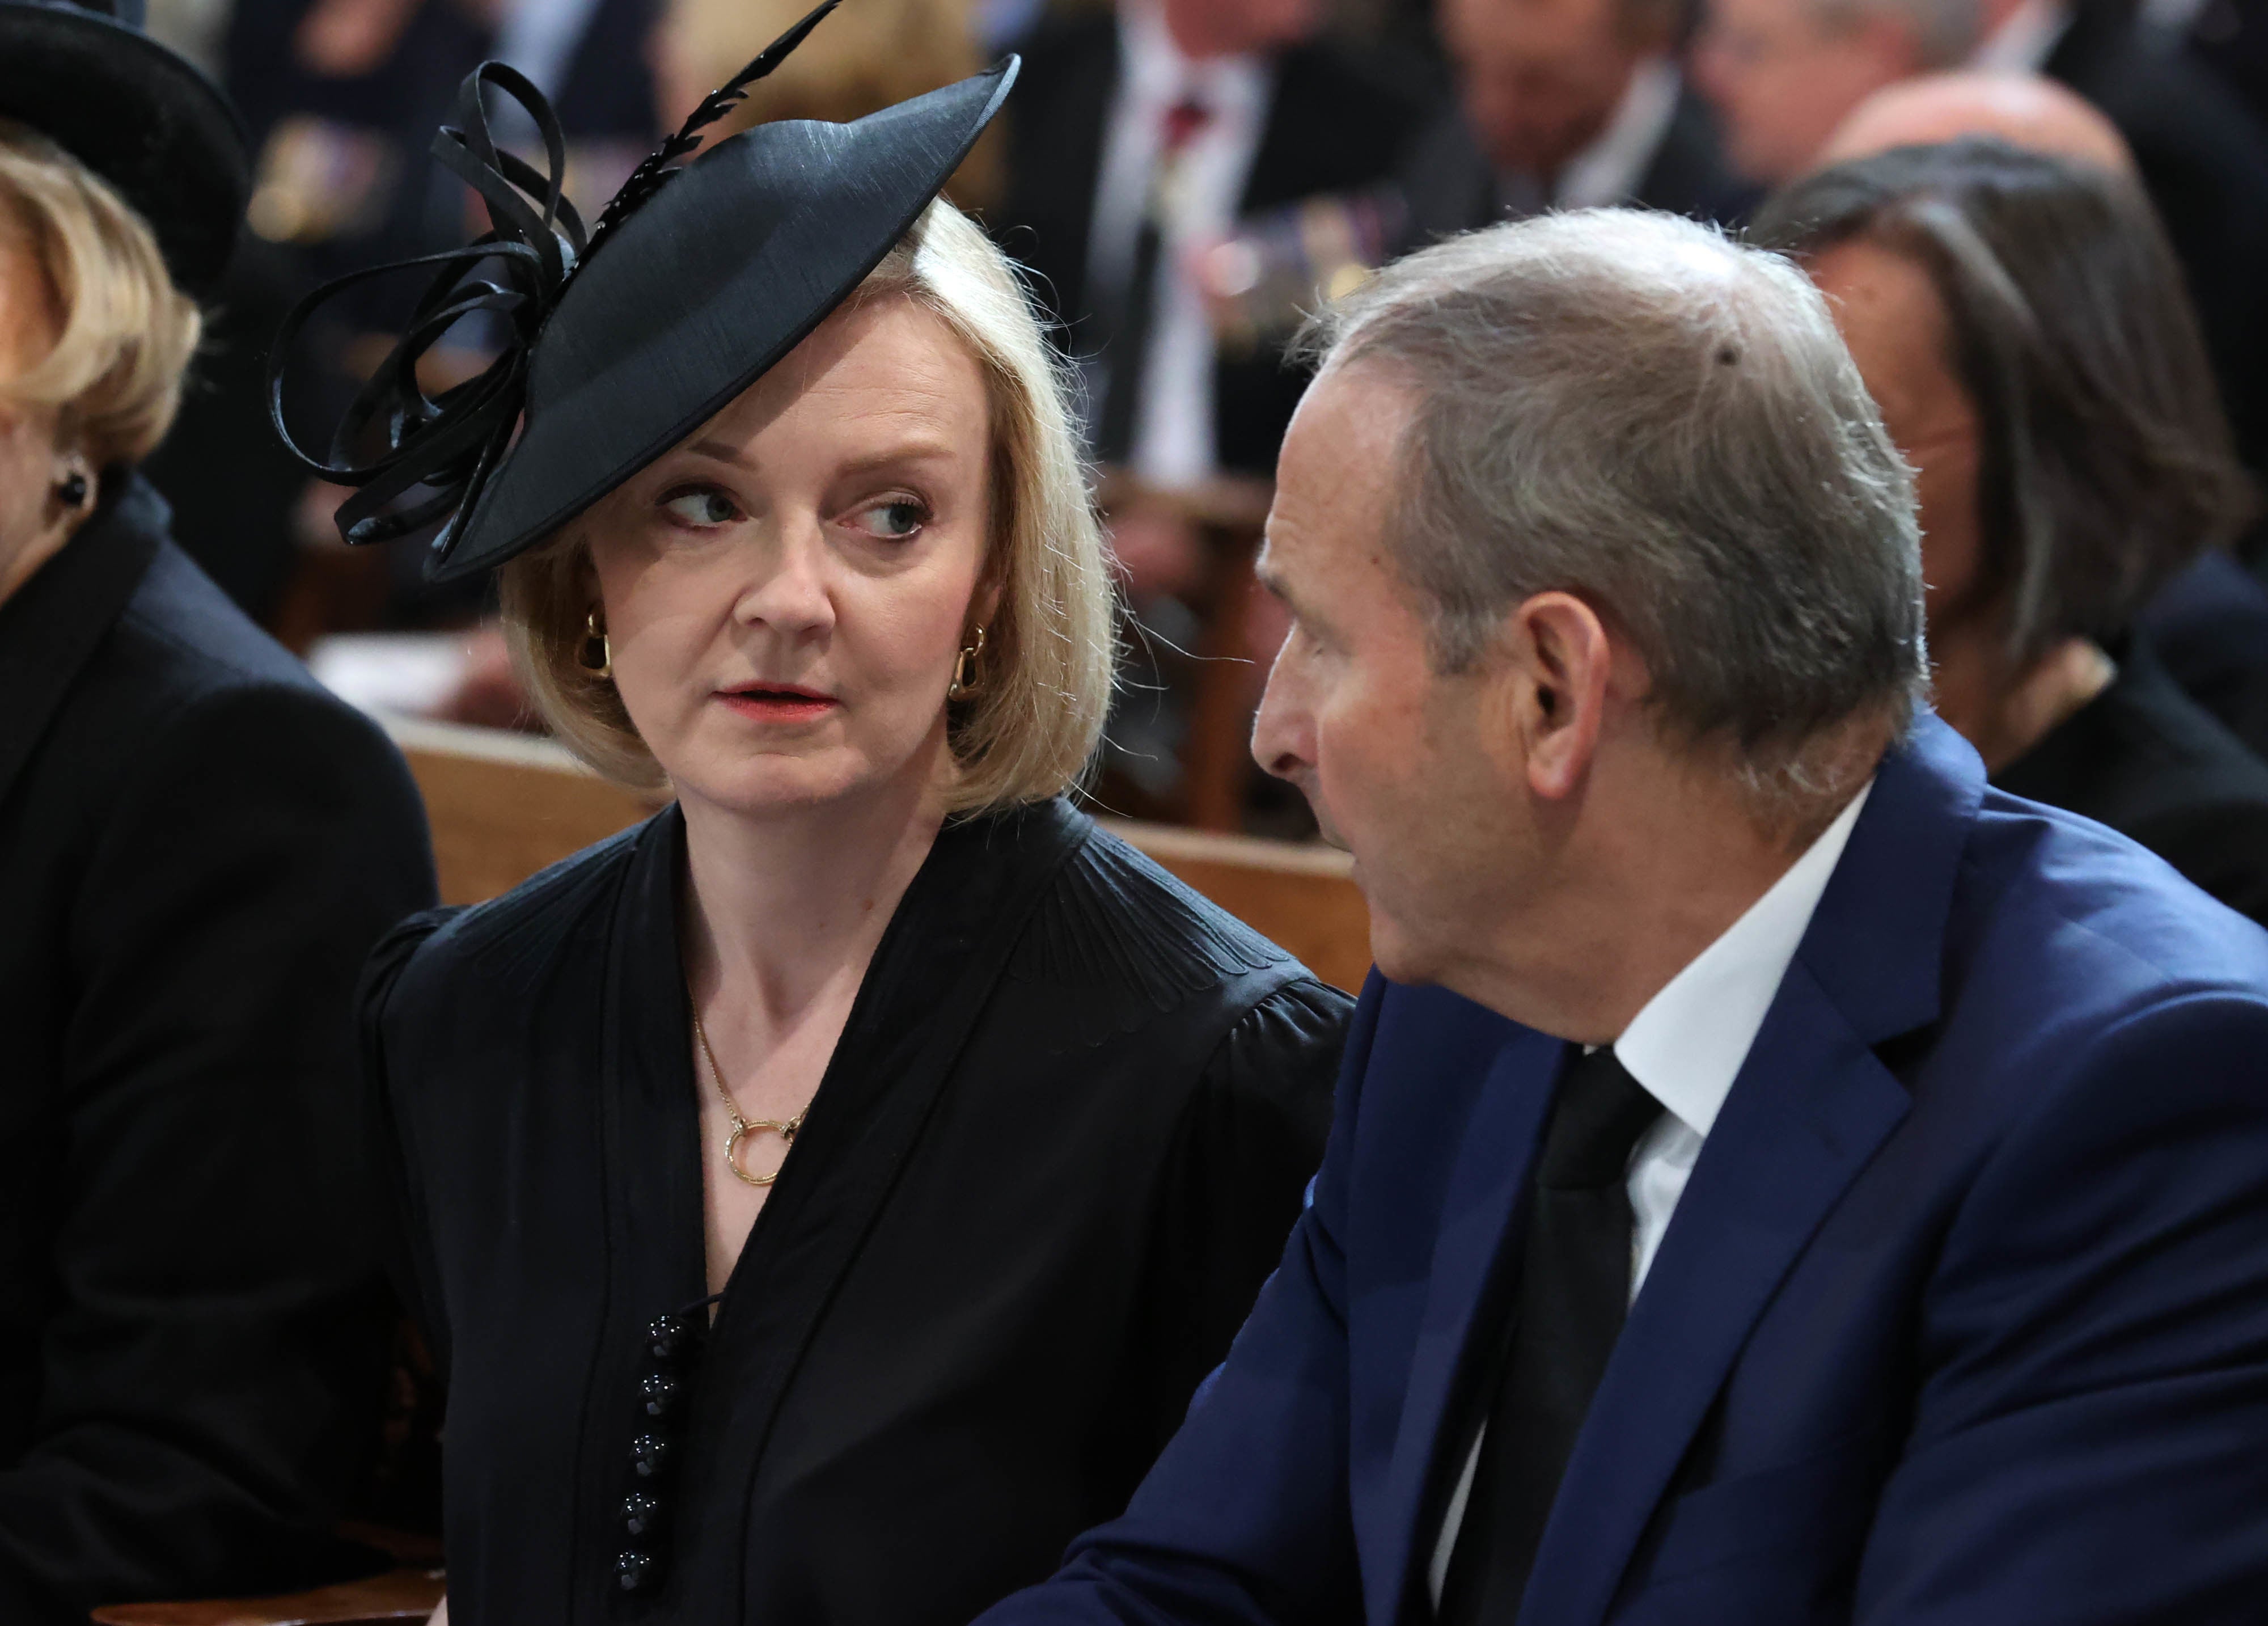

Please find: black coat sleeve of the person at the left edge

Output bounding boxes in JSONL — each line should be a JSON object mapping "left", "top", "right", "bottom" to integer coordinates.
{"left": 0, "top": 683, "right": 433, "bottom": 1626}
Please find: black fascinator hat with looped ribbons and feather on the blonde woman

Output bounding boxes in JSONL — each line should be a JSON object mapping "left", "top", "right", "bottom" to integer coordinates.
{"left": 270, "top": 0, "right": 1016, "bottom": 581}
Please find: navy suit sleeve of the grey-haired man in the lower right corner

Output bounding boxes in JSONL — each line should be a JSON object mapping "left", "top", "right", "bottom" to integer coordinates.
{"left": 1853, "top": 995, "right": 2268, "bottom": 1626}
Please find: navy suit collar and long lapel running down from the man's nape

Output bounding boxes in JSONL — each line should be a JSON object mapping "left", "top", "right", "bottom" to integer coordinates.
{"left": 1461, "top": 715, "right": 1984, "bottom": 1626}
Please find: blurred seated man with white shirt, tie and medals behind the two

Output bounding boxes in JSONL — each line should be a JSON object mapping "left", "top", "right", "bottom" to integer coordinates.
{"left": 989, "top": 0, "right": 1424, "bottom": 816}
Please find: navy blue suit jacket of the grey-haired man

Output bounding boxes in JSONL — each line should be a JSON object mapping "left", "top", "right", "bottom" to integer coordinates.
{"left": 984, "top": 717, "right": 2268, "bottom": 1626}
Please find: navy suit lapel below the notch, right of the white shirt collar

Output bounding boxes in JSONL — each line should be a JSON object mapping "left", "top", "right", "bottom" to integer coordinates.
{"left": 1520, "top": 964, "right": 1907, "bottom": 1624}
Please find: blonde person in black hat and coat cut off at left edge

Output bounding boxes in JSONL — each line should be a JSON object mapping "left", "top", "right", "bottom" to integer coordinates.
{"left": 0, "top": 0, "right": 433, "bottom": 1626}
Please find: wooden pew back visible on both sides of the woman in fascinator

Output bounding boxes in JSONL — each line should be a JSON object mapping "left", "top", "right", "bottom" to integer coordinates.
{"left": 388, "top": 719, "right": 1370, "bottom": 989}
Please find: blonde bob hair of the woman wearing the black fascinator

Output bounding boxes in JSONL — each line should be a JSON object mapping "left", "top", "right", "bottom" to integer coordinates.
{"left": 499, "top": 200, "right": 1114, "bottom": 814}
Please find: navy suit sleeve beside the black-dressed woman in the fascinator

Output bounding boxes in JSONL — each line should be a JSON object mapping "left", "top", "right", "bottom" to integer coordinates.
{"left": 982, "top": 977, "right": 1383, "bottom": 1626}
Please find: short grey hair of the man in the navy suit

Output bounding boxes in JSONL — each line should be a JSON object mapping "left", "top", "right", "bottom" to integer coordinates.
{"left": 1304, "top": 209, "right": 1928, "bottom": 801}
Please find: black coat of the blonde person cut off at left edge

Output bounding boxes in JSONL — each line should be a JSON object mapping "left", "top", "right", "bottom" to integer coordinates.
{"left": 0, "top": 472, "right": 433, "bottom": 1626}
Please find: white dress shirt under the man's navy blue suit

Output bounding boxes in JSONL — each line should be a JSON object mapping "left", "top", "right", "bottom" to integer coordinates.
{"left": 1427, "top": 780, "right": 1873, "bottom": 1608}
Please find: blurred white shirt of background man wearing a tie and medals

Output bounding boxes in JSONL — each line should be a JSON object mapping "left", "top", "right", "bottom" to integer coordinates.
{"left": 1086, "top": 0, "right": 1275, "bottom": 488}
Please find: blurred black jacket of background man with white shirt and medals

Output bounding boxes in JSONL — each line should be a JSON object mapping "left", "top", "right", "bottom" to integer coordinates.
{"left": 989, "top": 9, "right": 1422, "bottom": 474}
